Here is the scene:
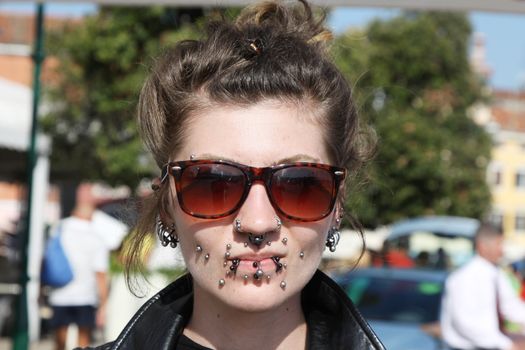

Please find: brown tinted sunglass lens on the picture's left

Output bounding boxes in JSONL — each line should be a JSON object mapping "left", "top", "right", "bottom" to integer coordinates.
{"left": 180, "top": 164, "right": 246, "bottom": 217}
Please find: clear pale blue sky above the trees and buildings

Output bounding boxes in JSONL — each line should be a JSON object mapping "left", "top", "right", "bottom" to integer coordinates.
{"left": 0, "top": 2, "right": 525, "bottom": 90}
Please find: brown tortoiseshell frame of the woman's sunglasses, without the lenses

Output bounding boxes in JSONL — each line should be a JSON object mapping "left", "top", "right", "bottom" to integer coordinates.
{"left": 161, "top": 159, "right": 346, "bottom": 222}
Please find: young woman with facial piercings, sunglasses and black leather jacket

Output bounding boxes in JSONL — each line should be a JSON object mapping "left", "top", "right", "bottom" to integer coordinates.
{"left": 90, "top": 1, "right": 383, "bottom": 350}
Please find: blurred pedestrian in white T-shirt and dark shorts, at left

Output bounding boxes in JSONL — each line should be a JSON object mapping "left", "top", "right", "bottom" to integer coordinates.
{"left": 49, "top": 184, "right": 109, "bottom": 350}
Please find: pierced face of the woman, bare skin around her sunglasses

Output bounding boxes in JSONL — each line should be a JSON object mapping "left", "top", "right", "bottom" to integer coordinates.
{"left": 170, "top": 100, "right": 335, "bottom": 311}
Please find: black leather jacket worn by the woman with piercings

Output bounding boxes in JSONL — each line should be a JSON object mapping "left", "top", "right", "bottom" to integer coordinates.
{"left": 87, "top": 271, "right": 384, "bottom": 350}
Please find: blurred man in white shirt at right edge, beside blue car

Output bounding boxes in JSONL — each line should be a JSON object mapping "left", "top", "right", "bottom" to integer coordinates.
{"left": 440, "top": 224, "right": 525, "bottom": 350}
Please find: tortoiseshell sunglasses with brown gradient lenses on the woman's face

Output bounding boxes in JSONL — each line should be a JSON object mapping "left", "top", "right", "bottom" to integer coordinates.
{"left": 161, "top": 160, "right": 346, "bottom": 221}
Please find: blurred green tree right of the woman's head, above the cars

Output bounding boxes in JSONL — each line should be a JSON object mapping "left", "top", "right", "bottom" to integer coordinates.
{"left": 333, "top": 12, "right": 491, "bottom": 227}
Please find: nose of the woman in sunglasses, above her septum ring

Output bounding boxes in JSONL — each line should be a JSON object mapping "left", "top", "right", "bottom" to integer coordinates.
{"left": 236, "top": 183, "right": 280, "bottom": 235}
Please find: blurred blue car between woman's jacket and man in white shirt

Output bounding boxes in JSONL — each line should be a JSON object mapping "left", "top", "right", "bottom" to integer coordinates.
{"left": 333, "top": 268, "right": 447, "bottom": 350}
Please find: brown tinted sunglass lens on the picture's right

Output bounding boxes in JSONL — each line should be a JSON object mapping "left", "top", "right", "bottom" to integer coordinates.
{"left": 270, "top": 166, "right": 334, "bottom": 220}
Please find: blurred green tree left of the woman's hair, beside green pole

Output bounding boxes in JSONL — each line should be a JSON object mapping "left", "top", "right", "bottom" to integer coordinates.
{"left": 42, "top": 7, "right": 202, "bottom": 188}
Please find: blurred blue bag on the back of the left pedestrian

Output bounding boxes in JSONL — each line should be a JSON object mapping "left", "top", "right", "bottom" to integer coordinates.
{"left": 41, "top": 224, "right": 73, "bottom": 288}
